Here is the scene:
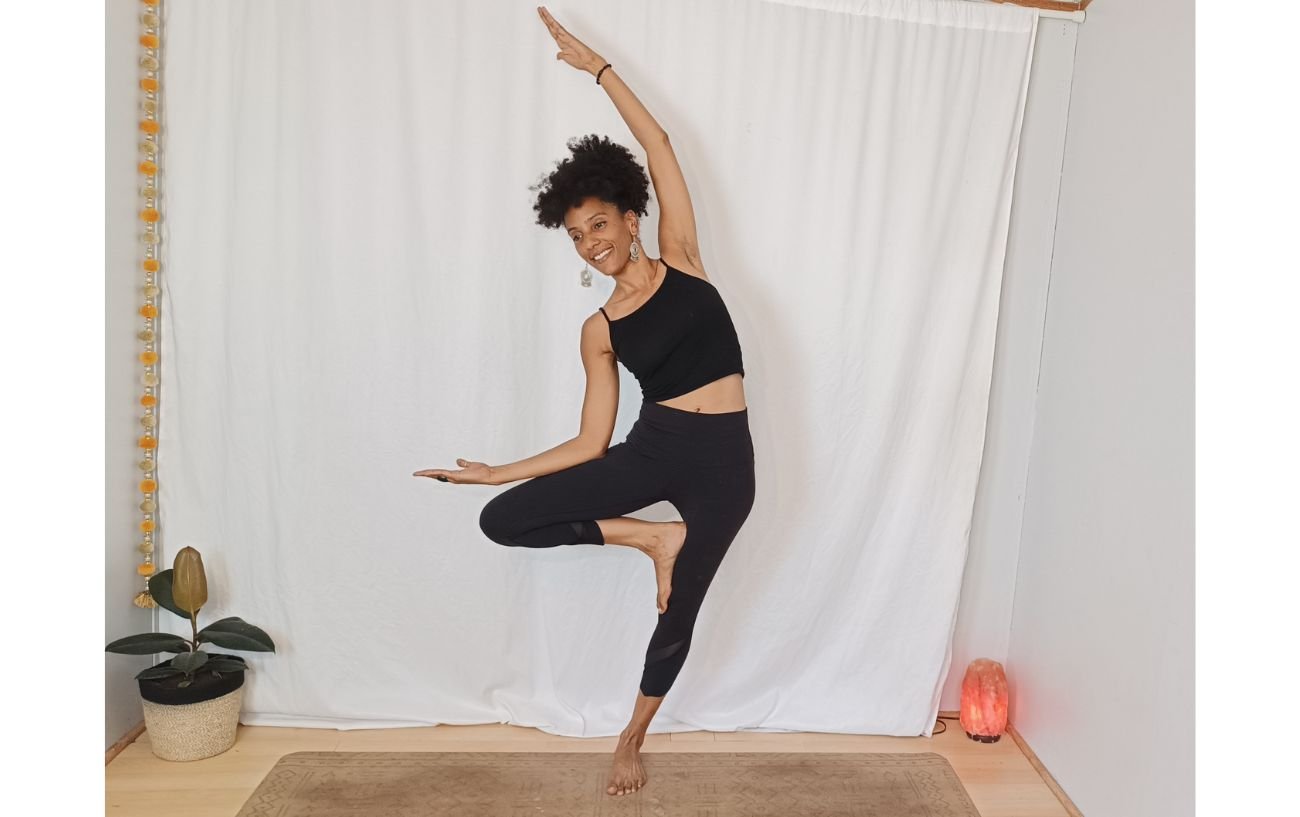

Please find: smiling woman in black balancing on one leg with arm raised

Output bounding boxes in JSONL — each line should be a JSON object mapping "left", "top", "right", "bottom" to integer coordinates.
{"left": 416, "top": 7, "right": 754, "bottom": 795}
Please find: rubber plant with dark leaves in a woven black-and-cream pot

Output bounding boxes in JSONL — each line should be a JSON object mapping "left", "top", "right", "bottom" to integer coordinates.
{"left": 104, "top": 548, "right": 276, "bottom": 760}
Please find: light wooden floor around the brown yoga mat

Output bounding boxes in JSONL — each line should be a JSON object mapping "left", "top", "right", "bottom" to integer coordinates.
{"left": 104, "top": 721, "right": 1069, "bottom": 817}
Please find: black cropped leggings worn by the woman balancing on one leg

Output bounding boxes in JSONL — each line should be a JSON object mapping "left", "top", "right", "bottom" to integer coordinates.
{"left": 478, "top": 401, "right": 754, "bottom": 697}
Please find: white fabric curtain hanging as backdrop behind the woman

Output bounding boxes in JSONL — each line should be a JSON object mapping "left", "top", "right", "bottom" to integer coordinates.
{"left": 157, "top": 0, "right": 1036, "bottom": 736}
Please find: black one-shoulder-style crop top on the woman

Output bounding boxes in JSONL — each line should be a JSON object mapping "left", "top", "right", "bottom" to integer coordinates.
{"left": 601, "top": 261, "right": 745, "bottom": 402}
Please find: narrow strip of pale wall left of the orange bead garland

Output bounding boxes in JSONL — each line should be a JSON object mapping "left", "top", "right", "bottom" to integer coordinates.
{"left": 104, "top": 0, "right": 153, "bottom": 749}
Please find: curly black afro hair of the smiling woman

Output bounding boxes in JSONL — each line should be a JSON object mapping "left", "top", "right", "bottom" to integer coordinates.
{"left": 529, "top": 134, "right": 650, "bottom": 229}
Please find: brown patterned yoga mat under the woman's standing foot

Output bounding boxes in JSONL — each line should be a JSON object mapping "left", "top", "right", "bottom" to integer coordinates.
{"left": 237, "top": 752, "right": 979, "bottom": 817}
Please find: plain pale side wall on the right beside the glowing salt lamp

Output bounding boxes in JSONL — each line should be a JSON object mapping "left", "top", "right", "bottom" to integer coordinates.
{"left": 1008, "top": 0, "right": 1195, "bottom": 817}
